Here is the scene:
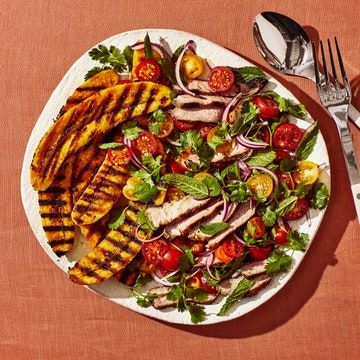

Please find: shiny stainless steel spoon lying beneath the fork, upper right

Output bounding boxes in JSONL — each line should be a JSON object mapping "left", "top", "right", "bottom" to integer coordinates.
{"left": 253, "top": 11, "right": 360, "bottom": 128}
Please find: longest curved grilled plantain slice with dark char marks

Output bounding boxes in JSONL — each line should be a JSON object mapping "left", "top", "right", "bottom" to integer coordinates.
{"left": 30, "top": 81, "right": 171, "bottom": 190}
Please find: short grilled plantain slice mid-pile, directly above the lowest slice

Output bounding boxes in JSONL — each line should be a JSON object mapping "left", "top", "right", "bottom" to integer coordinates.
{"left": 71, "top": 155, "right": 129, "bottom": 225}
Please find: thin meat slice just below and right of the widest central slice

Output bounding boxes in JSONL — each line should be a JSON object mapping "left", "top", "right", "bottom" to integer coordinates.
{"left": 164, "top": 201, "right": 224, "bottom": 239}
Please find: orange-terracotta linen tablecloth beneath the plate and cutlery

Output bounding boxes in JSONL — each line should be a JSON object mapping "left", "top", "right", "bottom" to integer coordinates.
{"left": 0, "top": 0, "right": 360, "bottom": 360}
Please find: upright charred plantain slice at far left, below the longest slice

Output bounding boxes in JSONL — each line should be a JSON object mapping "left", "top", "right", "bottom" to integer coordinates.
{"left": 38, "top": 159, "right": 75, "bottom": 257}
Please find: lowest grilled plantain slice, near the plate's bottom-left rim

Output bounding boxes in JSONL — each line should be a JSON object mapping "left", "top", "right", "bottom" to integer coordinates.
{"left": 68, "top": 222, "right": 141, "bottom": 285}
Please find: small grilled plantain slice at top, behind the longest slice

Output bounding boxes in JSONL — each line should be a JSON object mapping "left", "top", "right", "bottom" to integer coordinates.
{"left": 59, "top": 70, "right": 120, "bottom": 116}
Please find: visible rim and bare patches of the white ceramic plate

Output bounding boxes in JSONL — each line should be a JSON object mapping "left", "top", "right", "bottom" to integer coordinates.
{"left": 21, "top": 29, "right": 330, "bottom": 324}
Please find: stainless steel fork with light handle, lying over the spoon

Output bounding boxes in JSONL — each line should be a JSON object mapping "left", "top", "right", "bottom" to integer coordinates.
{"left": 312, "top": 37, "right": 360, "bottom": 222}
